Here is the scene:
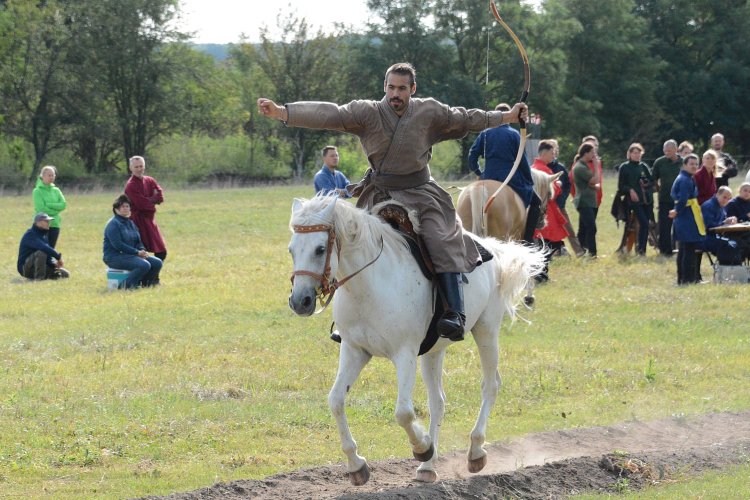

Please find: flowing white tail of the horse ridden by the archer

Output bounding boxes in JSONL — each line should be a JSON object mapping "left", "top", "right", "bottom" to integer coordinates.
{"left": 482, "top": 238, "right": 544, "bottom": 318}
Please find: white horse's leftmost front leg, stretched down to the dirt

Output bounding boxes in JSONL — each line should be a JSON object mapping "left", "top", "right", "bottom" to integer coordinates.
{"left": 328, "top": 342, "right": 372, "bottom": 486}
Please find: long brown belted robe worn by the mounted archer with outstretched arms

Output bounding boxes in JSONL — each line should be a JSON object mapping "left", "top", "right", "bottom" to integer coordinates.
{"left": 286, "top": 97, "right": 502, "bottom": 273}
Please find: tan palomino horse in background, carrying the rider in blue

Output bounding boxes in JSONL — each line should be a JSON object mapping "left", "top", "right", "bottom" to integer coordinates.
{"left": 456, "top": 168, "right": 563, "bottom": 305}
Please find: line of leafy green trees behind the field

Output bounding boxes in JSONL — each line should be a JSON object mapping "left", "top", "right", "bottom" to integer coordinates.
{"left": 0, "top": 0, "right": 750, "bottom": 189}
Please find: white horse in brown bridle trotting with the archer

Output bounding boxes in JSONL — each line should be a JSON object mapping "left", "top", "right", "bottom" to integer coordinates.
{"left": 289, "top": 197, "right": 544, "bottom": 486}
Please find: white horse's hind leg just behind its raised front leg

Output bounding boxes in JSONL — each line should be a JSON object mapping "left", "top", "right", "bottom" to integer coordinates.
{"left": 416, "top": 349, "right": 445, "bottom": 483}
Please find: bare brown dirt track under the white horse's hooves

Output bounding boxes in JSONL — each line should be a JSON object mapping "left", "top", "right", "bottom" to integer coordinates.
{"left": 132, "top": 411, "right": 750, "bottom": 500}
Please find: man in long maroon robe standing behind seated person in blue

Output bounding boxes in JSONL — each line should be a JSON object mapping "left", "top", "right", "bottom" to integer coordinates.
{"left": 125, "top": 156, "right": 167, "bottom": 261}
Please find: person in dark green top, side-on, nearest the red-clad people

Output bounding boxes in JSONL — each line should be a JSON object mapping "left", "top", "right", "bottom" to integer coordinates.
{"left": 571, "top": 142, "right": 601, "bottom": 257}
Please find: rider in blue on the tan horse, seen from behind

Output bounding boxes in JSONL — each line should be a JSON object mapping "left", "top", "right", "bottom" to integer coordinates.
{"left": 469, "top": 103, "right": 542, "bottom": 244}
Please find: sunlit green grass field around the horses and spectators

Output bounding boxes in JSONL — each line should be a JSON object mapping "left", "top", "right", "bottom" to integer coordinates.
{"left": 0, "top": 181, "right": 750, "bottom": 499}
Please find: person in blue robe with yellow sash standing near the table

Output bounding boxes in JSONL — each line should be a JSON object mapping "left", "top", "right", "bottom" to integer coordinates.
{"left": 669, "top": 154, "right": 706, "bottom": 285}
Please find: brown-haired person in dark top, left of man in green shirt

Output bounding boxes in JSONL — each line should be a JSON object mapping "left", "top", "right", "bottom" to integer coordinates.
{"left": 617, "top": 142, "right": 654, "bottom": 255}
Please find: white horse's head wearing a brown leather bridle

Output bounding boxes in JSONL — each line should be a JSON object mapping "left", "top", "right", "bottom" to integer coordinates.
{"left": 289, "top": 197, "right": 338, "bottom": 316}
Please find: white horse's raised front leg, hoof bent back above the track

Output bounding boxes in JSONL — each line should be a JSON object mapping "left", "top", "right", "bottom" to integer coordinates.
{"left": 391, "top": 352, "right": 435, "bottom": 462}
